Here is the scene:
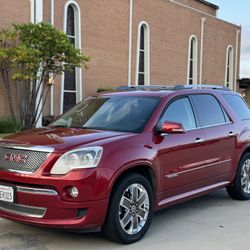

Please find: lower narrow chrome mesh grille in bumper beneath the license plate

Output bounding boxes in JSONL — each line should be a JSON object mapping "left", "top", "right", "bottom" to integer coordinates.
{"left": 0, "top": 201, "right": 46, "bottom": 218}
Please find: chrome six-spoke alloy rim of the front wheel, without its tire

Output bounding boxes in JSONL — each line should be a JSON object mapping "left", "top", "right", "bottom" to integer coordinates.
{"left": 119, "top": 183, "right": 150, "bottom": 235}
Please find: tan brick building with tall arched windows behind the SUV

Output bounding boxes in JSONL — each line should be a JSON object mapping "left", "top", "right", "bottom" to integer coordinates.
{"left": 0, "top": 0, "right": 241, "bottom": 121}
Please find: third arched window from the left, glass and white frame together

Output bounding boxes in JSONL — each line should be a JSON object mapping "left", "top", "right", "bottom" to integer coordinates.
{"left": 187, "top": 36, "right": 198, "bottom": 84}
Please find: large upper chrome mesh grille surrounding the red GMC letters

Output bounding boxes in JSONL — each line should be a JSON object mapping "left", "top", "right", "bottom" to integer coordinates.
{"left": 0, "top": 147, "right": 49, "bottom": 173}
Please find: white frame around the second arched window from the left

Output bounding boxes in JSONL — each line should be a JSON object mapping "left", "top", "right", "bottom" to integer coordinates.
{"left": 135, "top": 21, "right": 150, "bottom": 85}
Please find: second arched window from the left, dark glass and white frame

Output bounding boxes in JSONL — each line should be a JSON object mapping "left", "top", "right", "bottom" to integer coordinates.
{"left": 136, "top": 22, "right": 150, "bottom": 85}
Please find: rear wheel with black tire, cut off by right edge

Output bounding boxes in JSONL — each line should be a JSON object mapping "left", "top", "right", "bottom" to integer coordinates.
{"left": 227, "top": 153, "right": 250, "bottom": 200}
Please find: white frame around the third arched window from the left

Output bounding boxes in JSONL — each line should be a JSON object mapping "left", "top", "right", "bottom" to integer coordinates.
{"left": 187, "top": 35, "right": 198, "bottom": 84}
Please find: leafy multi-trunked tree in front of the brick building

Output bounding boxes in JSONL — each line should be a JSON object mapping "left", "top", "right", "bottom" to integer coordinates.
{"left": 0, "top": 23, "right": 89, "bottom": 129}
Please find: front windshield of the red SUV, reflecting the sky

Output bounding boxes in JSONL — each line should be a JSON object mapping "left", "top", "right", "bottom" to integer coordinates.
{"left": 50, "top": 96, "right": 159, "bottom": 133}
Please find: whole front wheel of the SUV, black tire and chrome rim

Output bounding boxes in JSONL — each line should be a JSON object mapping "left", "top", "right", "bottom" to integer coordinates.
{"left": 102, "top": 173, "right": 154, "bottom": 244}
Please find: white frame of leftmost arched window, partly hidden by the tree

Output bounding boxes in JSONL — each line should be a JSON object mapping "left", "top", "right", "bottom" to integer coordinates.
{"left": 60, "top": 0, "right": 83, "bottom": 114}
